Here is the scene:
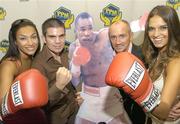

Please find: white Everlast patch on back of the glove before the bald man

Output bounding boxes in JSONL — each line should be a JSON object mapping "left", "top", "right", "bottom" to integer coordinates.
{"left": 124, "top": 61, "right": 145, "bottom": 90}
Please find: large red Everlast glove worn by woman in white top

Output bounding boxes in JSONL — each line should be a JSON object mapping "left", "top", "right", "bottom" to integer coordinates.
{"left": 105, "top": 52, "right": 160, "bottom": 112}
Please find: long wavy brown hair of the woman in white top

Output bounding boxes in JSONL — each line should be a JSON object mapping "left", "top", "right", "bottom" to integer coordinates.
{"left": 143, "top": 5, "right": 180, "bottom": 81}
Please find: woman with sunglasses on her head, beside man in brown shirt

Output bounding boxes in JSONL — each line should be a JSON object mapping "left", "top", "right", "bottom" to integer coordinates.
{"left": 0, "top": 19, "right": 46, "bottom": 124}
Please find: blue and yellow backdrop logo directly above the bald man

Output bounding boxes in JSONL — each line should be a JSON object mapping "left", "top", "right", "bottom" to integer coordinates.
{"left": 100, "top": 4, "right": 122, "bottom": 26}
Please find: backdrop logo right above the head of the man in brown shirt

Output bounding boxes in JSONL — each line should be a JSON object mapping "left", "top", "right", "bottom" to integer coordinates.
{"left": 53, "top": 7, "right": 74, "bottom": 29}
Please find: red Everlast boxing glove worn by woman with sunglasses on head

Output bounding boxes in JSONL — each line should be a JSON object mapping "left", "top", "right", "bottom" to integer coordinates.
{"left": 2, "top": 69, "right": 48, "bottom": 117}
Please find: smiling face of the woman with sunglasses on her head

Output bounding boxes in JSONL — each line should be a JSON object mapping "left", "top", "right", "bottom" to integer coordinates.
{"left": 16, "top": 26, "right": 39, "bottom": 56}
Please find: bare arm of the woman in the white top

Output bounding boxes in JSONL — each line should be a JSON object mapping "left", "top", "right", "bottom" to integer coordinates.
{"left": 152, "top": 58, "right": 180, "bottom": 120}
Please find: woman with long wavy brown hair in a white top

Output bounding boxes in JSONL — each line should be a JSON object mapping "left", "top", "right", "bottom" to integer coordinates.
{"left": 143, "top": 6, "right": 180, "bottom": 124}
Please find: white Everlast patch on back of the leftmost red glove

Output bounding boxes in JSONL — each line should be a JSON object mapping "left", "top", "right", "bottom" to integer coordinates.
{"left": 11, "top": 81, "right": 23, "bottom": 106}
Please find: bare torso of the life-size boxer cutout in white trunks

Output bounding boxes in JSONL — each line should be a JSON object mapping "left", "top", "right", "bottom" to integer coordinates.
{"left": 82, "top": 41, "right": 113, "bottom": 87}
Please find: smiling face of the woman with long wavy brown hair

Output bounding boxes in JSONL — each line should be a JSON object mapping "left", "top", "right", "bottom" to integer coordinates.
{"left": 148, "top": 15, "right": 168, "bottom": 50}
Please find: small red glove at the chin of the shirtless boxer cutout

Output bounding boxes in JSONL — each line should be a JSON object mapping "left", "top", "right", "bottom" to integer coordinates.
{"left": 72, "top": 46, "right": 91, "bottom": 66}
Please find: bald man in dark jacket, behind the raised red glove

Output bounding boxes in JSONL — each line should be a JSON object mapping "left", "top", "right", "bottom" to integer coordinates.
{"left": 109, "top": 20, "right": 146, "bottom": 124}
